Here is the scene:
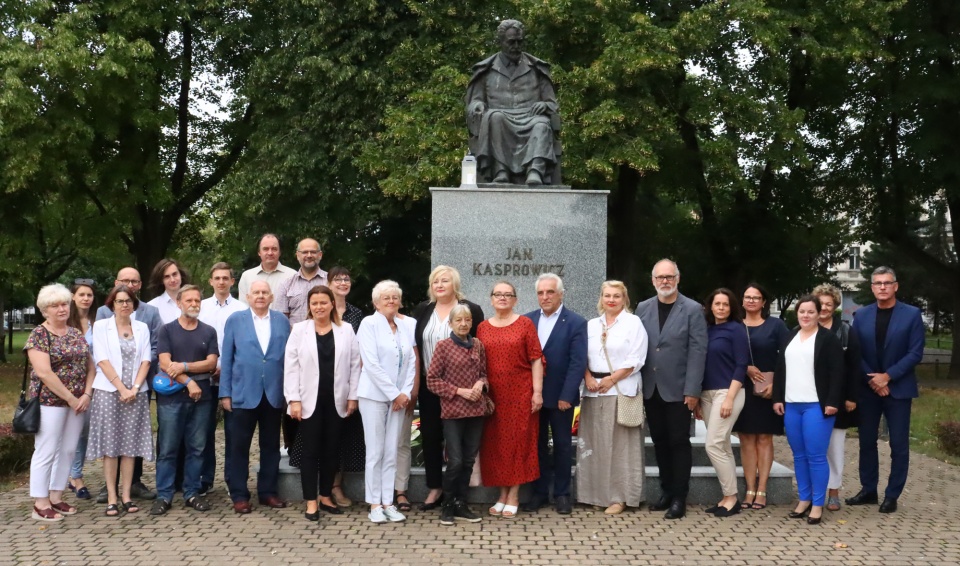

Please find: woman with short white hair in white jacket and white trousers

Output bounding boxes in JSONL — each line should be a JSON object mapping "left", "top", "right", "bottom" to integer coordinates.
{"left": 357, "top": 280, "right": 417, "bottom": 523}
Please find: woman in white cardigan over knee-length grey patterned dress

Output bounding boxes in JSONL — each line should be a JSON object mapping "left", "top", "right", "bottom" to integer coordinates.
{"left": 87, "top": 285, "right": 154, "bottom": 517}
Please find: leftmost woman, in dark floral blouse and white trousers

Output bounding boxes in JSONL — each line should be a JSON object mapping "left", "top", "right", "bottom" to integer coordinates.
{"left": 23, "top": 284, "right": 96, "bottom": 522}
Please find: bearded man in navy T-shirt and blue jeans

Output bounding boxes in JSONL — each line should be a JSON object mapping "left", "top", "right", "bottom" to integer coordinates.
{"left": 150, "top": 285, "right": 219, "bottom": 515}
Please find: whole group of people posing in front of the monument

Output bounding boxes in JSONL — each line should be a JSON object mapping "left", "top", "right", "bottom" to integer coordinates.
{"left": 24, "top": 234, "right": 923, "bottom": 525}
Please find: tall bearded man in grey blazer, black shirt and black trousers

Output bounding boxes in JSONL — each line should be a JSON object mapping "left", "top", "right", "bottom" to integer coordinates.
{"left": 637, "top": 259, "right": 707, "bottom": 519}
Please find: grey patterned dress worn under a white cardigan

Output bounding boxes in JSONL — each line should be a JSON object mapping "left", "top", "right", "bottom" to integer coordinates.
{"left": 87, "top": 338, "right": 153, "bottom": 462}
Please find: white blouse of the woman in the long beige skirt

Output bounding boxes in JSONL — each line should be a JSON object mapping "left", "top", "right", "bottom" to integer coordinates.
{"left": 580, "top": 310, "right": 647, "bottom": 397}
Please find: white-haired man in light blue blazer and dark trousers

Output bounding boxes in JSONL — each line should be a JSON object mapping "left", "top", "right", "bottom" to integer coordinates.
{"left": 220, "top": 281, "right": 290, "bottom": 515}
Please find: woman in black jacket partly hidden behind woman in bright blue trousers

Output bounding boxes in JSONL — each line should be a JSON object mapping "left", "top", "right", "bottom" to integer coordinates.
{"left": 813, "top": 284, "right": 860, "bottom": 511}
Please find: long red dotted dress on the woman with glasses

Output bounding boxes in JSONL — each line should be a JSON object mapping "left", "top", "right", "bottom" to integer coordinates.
{"left": 477, "top": 316, "right": 543, "bottom": 487}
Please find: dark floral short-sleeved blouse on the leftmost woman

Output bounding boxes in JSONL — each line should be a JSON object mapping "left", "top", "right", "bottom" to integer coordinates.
{"left": 23, "top": 325, "right": 90, "bottom": 407}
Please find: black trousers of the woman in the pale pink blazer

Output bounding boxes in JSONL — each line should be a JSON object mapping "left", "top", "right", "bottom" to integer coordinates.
{"left": 298, "top": 393, "right": 343, "bottom": 500}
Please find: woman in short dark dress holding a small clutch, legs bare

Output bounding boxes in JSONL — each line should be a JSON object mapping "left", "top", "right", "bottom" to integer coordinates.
{"left": 733, "top": 283, "right": 788, "bottom": 509}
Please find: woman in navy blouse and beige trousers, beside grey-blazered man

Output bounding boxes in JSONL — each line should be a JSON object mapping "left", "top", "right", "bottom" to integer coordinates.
{"left": 697, "top": 289, "right": 750, "bottom": 517}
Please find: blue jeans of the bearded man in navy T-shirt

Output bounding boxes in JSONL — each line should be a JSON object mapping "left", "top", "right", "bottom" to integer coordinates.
{"left": 157, "top": 399, "right": 214, "bottom": 503}
